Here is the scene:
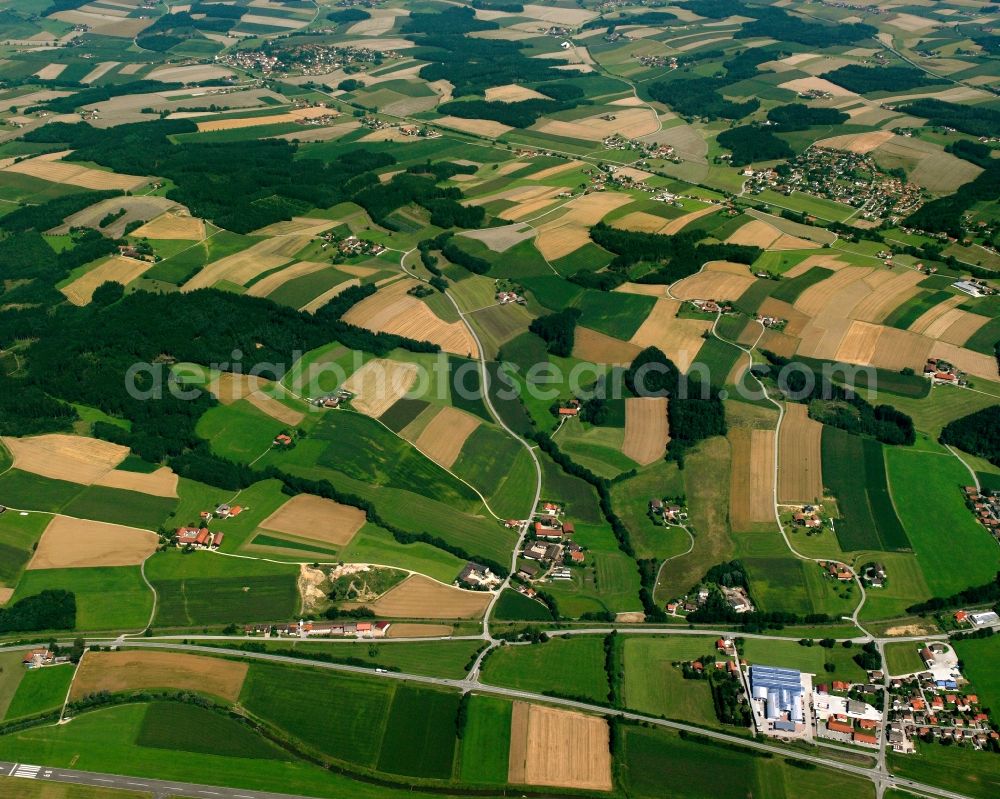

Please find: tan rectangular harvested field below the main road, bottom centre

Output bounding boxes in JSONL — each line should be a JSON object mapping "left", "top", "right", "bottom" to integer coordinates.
{"left": 507, "top": 702, "right": 612, "bottom": 791}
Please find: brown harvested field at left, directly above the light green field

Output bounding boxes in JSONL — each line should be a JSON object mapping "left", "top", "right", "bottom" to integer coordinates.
{"left": 28, "top": 516, "right": 160, "bottom": 569}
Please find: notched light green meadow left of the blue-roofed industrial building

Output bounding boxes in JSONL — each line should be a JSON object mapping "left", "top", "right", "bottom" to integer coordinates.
{"left": 622, "top": 636, "right": 722, "bottom": 727}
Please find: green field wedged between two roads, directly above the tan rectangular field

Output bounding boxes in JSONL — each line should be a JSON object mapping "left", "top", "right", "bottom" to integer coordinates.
{"left": 483, "top": 635, "right": 609, "bottom": 702}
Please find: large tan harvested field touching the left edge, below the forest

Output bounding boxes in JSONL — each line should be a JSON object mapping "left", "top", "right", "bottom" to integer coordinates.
{"left": 2, "top": 433, "right": 128, "bottom": 485}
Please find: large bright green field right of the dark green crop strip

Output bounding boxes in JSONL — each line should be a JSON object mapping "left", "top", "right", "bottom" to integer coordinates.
{"left": 884, "top": 447, "right": 997, "bottom": 596}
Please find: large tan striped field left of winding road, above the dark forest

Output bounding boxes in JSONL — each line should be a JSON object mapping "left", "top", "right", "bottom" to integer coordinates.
{"left": 344, "top": 279, "right": 479, "bottom": 357}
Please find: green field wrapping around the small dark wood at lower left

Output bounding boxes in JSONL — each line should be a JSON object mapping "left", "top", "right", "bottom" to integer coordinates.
{"left": 12, "top": 566, "right": 153, "bottom": 631}
